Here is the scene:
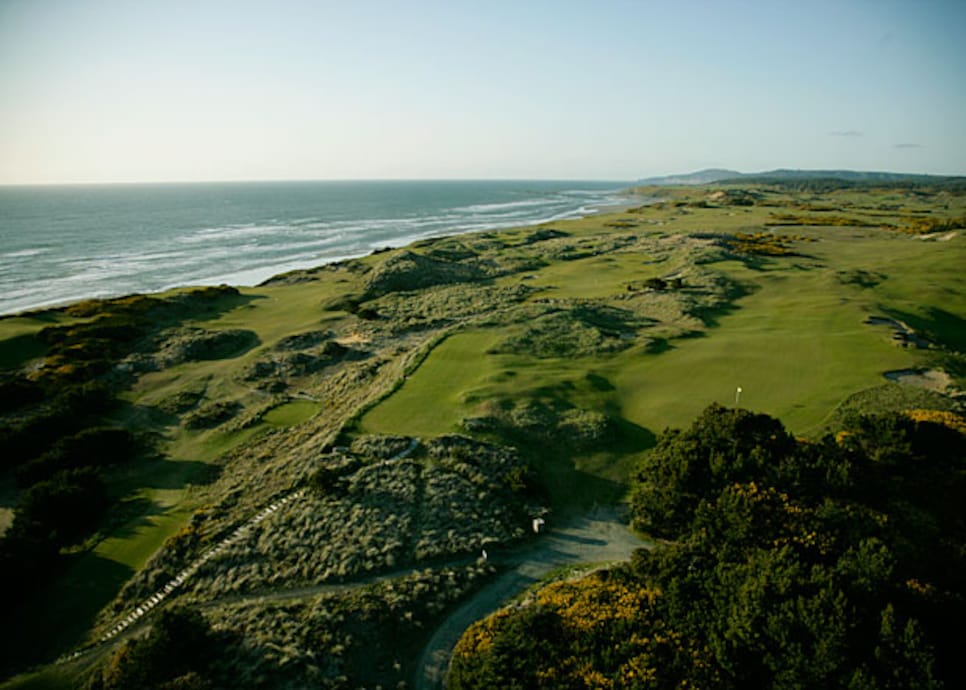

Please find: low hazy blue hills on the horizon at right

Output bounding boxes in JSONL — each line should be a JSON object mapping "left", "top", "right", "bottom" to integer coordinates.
{"left": 638, "top": 168, "right": 966, "bottom": 186}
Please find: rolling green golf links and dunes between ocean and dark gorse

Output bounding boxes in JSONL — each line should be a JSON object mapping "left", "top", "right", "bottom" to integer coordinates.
{"left": 0, "top": 184, "right": 966, "bottom": 688}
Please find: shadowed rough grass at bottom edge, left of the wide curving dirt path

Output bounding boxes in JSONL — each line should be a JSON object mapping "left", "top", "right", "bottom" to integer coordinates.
{"left": 129, "top": 565, "right": 493, "bottom": 690}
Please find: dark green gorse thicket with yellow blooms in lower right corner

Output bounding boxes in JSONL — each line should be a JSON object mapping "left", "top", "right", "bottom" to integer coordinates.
{"left": 449, "top": 406, "right": 966, "bottom": 690}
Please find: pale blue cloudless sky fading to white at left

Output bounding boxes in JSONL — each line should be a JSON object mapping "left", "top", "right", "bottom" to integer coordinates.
{"left": 0, "top": 0, "right": 966, "bottom": 184}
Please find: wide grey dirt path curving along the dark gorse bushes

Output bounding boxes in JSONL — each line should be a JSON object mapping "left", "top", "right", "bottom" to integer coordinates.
{"left": 413, "top": 507, "right": 648, "bottom": 690}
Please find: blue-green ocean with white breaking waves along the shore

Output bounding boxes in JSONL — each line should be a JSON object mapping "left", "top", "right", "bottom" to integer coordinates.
{"left": 0, "top": 181, "right": 628, "bottom": 314}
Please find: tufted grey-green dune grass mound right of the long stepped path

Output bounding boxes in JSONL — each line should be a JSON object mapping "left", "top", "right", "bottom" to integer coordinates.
{"left": 114, "top": 436, "right": 540, "bottom": 613}
